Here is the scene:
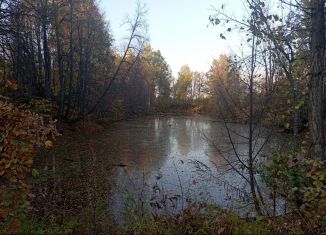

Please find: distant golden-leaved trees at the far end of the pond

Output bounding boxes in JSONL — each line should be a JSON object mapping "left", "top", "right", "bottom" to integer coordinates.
{"left": 171, "top": 54, "right": 249, "bottom": 116}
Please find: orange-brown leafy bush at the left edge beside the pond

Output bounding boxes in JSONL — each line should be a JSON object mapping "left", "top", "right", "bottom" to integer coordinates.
{"left": 0, "top": 94, "right": 58, "bottom": 233}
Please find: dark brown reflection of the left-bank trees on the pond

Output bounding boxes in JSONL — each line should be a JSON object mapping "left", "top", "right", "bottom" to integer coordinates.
{"left": 34, "top": 118, "right": 177, "bottom": 229}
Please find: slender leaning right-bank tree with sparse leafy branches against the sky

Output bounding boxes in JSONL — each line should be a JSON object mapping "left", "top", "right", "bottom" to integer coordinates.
{"left": 210, "top": 0, "right": 301, "bottom": 137}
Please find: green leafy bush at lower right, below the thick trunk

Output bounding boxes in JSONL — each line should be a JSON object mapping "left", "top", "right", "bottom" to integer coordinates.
{"left": 265, "top": 148, "right": 326, "bottom": 228}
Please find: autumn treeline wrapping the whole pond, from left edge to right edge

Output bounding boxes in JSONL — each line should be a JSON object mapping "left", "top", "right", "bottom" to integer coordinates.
{"left": 0, "top": 0, "right": 325, "bottom": 153}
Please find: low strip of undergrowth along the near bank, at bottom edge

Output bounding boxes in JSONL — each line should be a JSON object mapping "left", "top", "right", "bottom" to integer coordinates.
{"left": 14, "top": 204, "right": 325, "bottom": 235}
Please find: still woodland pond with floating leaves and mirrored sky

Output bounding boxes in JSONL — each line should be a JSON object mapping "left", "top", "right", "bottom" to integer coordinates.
{"left": 34, "top": 116, "right": 280, "bottom": 224}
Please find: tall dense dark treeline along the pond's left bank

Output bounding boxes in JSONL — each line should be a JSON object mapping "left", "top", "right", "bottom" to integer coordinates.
{"left": 0, "top": 0, "right": 171, "bottom": 121}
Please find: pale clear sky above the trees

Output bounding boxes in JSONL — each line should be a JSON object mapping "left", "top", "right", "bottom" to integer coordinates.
{"left": 100, "top": 0, "right": 242, "bottom": 76}
